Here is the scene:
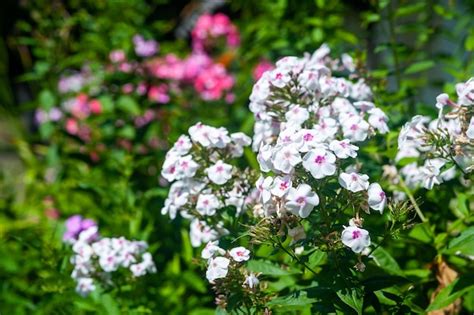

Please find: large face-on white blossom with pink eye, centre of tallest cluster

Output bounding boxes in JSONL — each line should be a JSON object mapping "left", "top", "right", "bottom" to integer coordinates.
{"left": 303, "top": 148, "right": 336, "bottom": 179}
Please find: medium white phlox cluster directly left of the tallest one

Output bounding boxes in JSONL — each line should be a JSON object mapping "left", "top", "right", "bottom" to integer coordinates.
{"left": 161, "top": 123, "right": 251, "bottom": 247}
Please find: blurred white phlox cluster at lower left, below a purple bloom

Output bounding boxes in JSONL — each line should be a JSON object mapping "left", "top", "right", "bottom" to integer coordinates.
{"left": 71, "top": 226, "right": 156, "bottom": 296}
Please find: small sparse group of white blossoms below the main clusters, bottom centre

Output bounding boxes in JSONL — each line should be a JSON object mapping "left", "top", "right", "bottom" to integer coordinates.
{"left": 201, "top": 241, "right": 254, "bottom": 289}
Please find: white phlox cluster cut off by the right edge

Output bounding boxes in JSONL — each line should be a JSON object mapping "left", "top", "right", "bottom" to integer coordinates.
{"left": 396, "top": 78, "right": 474, "bottom": 189}
